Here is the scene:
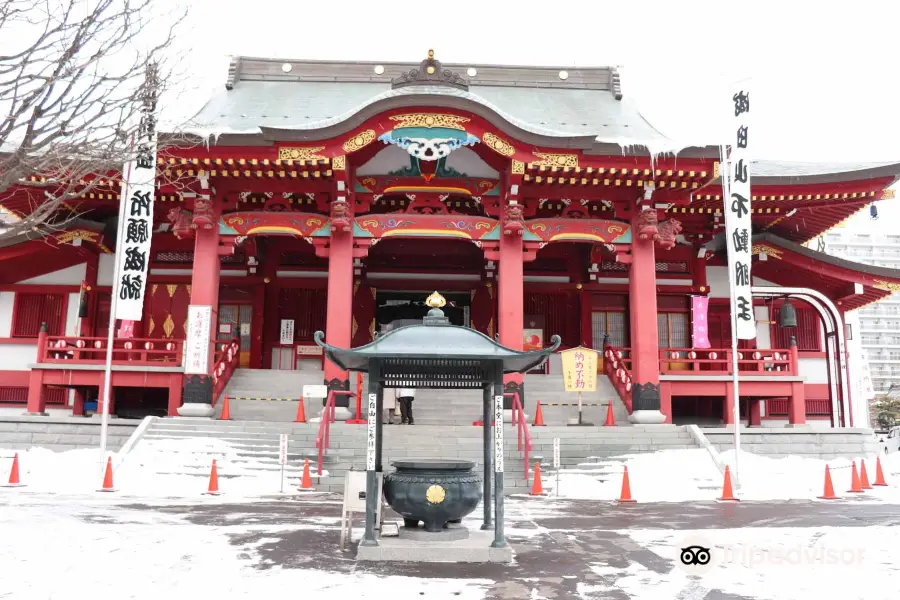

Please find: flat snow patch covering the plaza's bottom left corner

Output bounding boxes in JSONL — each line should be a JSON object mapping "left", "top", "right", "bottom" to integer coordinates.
{"left": 0, "top": 504, "right": 493, "bottom": 600}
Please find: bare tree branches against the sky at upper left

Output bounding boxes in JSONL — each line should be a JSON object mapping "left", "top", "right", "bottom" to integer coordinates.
{"left": 0, "top": 0, "right": 185, "bottom": 240}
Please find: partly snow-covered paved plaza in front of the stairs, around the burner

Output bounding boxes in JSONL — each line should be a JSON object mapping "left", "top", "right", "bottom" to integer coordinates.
{"left": 0, "top": 492, "right": 900, "bottom": 600}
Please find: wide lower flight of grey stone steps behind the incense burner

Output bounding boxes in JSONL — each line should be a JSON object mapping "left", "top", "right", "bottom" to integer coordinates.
{"left": 132, "top": 418, "right": 697, "bottom": 494}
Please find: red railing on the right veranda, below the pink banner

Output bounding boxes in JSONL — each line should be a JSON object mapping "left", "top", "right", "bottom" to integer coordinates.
{"left": 659, "top": 348, "right": 799, "bottom": 375}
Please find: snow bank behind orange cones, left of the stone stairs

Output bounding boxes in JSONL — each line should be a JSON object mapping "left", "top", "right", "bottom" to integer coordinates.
{"left": 0, "top": 438, "right": 328, "bottom": 501}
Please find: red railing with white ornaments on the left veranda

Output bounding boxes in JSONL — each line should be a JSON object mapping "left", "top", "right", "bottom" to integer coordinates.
{"left": 37, "top": 333, "right": 184, "bottom": 367}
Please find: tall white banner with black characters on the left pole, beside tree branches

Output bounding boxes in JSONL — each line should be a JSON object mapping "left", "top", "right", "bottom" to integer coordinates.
{"left": 113, "top": 65, "right": 160, "bottom": 322}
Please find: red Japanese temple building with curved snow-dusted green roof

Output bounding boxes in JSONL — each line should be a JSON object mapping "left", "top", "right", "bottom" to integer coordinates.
{"left": 0, "top": 53, "right": 900, "bottom": 427}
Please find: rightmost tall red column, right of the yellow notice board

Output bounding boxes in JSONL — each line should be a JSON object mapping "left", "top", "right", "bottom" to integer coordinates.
{"left": 628, "top": 208, "right": 672, "bottom": 424}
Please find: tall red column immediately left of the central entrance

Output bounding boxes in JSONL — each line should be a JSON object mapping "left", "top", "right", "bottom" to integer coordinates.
{"left": 325, "top": 179, "right": 353, "bottom": 396}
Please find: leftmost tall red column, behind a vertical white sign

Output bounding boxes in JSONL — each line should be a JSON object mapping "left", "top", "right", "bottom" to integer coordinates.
{"left": 178, "top": 194, "right": 221, "bottom": 416}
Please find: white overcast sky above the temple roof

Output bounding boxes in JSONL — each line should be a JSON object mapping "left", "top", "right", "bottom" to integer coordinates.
{"left": 179, "top": 0, "right": 900, "bottom": 162}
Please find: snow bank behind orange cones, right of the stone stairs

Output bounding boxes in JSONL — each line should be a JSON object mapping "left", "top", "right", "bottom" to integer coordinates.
{"left": 543, "top": 449, "right": 900, "bottom": 502}
